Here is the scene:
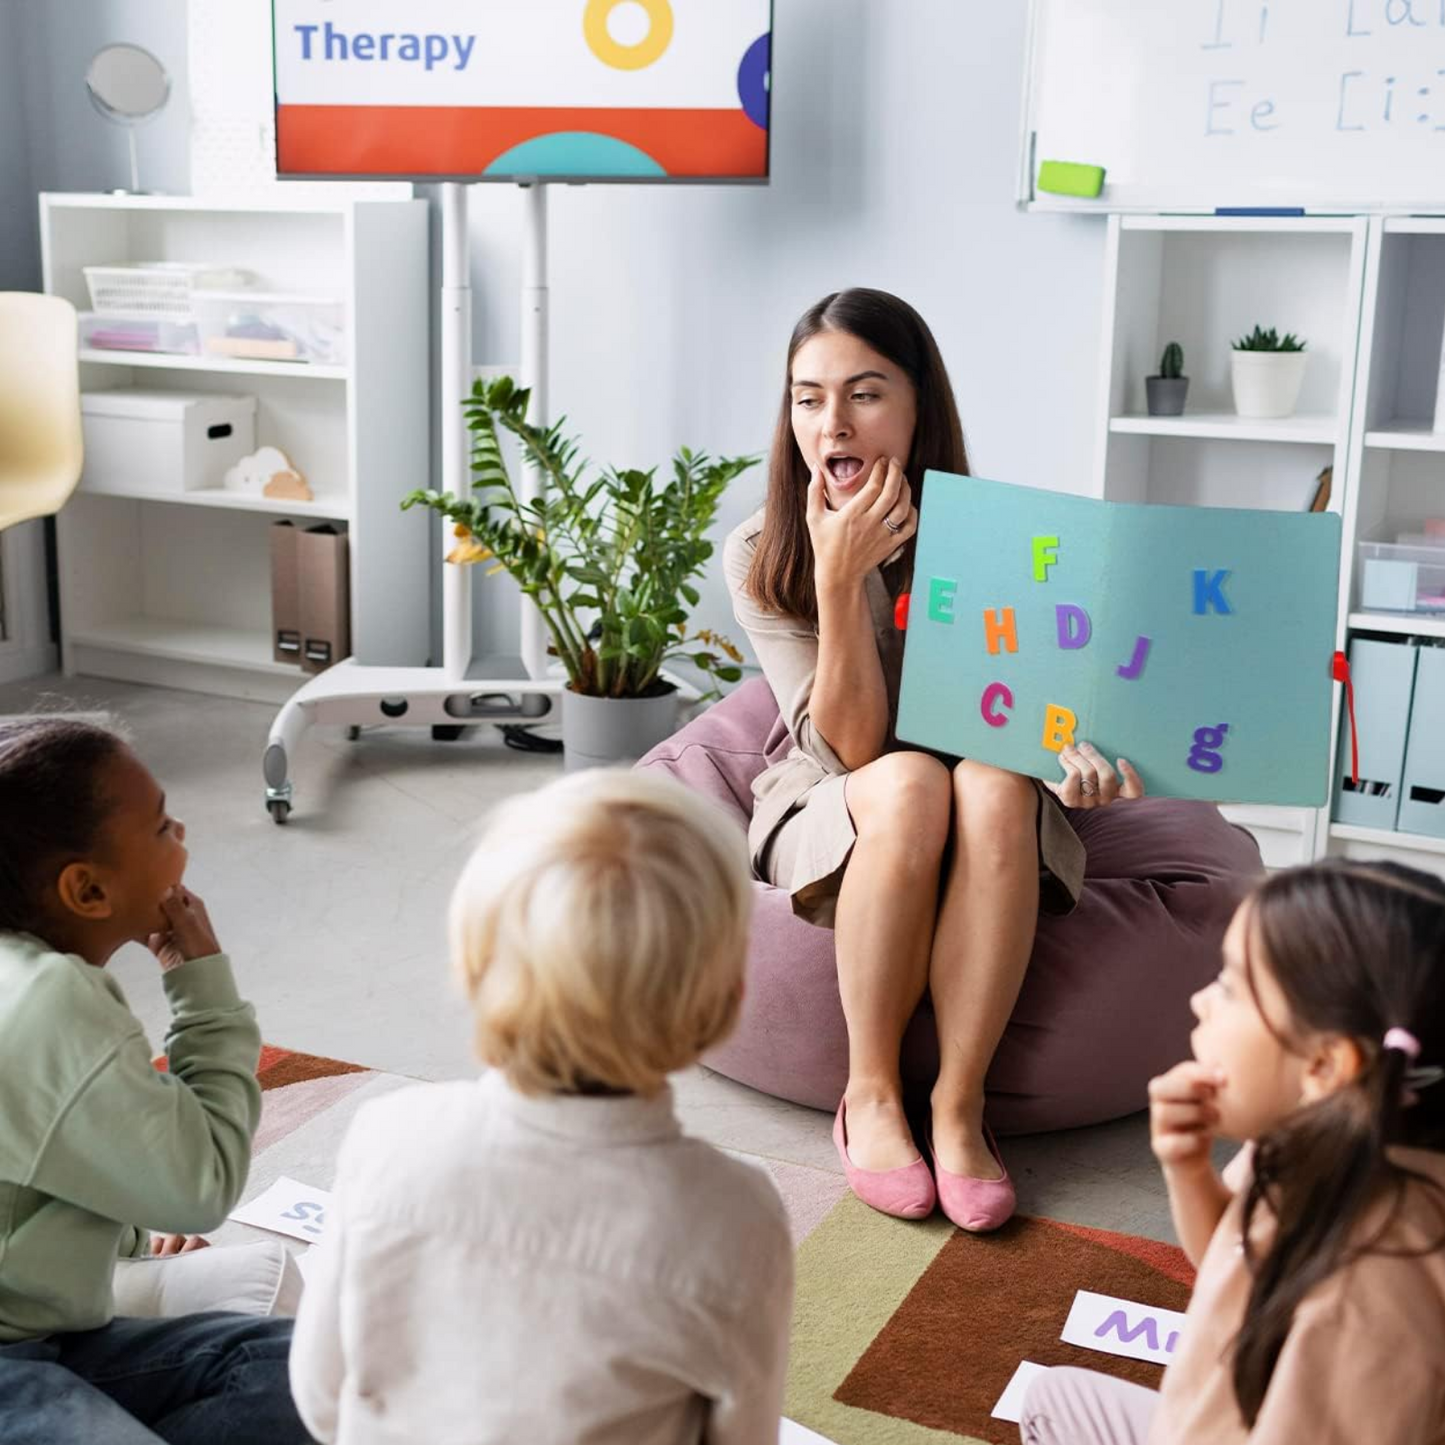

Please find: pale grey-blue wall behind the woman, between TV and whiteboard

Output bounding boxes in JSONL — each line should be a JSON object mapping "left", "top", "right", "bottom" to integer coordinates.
{"left": 456, "top": 0, "right": 1104, "bottom": 661}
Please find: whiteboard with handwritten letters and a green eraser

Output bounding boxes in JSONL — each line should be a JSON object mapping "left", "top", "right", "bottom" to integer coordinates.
{"left": 1020, "top": 0, "right": 1445, "bottom": 211}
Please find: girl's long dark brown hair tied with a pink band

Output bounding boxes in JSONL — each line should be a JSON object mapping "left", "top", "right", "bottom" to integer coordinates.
{"left": 1233, "top": 861, "right": 1445, "bottom": 1426}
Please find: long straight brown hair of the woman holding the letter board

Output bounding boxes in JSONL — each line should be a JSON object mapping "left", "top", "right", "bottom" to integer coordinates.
{"left": 747, "top": 286, "right": 968, "bottom": 627}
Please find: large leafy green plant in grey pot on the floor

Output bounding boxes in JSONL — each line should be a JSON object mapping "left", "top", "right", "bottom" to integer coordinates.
{"left": 402, "top": 377, "right": 759, "bottom": 769}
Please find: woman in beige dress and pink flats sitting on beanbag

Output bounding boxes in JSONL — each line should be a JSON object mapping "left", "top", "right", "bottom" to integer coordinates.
{"left": 724, "top": 289, "right": 1143, "bottom": 1230}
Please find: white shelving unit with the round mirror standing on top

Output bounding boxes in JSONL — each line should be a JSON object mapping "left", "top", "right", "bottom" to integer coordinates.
{"left": 40, "top": 194, "right": 431, "bottom": 702}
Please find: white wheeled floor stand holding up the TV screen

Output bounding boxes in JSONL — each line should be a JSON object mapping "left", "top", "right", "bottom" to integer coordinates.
{"left": 262, "top": 181, "right": 565, "bottom": 822}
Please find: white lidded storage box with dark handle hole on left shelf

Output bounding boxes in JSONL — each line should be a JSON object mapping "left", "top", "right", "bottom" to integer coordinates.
{"left": 81, "top": 386, "right": 256, "bottom": 497}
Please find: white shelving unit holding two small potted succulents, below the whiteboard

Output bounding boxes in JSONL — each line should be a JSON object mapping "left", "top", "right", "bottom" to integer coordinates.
{"left": 1092, "top": 215, "right": 1370, "bottom": 867}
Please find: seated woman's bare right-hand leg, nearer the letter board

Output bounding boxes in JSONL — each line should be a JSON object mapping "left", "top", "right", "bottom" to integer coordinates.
{"left": 928, "top": 762, "right": 1039, "bottom": 1179}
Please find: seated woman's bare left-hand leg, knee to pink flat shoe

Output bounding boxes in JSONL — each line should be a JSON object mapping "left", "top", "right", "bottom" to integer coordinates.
{"left": 834, "top": 753, "right": 952, "bottom": 1169}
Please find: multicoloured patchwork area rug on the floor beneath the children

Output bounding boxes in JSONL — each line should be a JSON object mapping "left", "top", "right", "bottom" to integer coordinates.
{"left": 215, "top": 1046, "right": 1194, "bottom": 1445}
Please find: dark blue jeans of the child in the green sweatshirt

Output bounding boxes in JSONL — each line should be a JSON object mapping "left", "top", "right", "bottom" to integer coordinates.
{"left": 0, "top": 1314, "right": 311, "bottom": 1445}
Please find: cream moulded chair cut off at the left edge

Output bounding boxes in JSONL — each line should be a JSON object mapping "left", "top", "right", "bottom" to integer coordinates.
{"left": 0, "top": 290, "right": 84, "bottom": 532}
